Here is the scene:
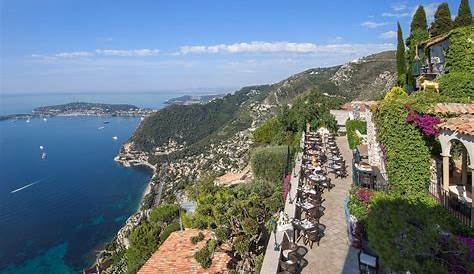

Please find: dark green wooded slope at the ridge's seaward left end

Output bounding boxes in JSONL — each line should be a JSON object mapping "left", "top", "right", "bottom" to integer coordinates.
{"left": 131, "top": 85, "right": 269, "bottom": 153}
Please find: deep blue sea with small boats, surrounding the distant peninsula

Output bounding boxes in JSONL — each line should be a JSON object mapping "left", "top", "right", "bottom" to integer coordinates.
{"left": 0, "top": 93, "right": 195, "bottom": 274}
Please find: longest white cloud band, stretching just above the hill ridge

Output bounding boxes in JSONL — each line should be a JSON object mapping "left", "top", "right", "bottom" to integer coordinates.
{"left": 180, "top": 41, "right": 392, "bottom": 54}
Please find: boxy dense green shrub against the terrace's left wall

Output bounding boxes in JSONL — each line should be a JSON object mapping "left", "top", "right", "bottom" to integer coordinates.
{"left": 250, "top": 146, "right": 288, "bottom": 182}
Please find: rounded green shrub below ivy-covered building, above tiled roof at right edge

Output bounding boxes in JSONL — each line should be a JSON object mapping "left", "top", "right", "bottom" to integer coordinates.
{"left": 439, "top": 72, "right": 474, "bottom": 100}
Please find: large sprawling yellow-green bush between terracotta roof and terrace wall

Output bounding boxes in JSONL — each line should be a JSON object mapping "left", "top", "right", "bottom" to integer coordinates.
{"left": 190, "top": 177, "right": 283, "bottom": 265}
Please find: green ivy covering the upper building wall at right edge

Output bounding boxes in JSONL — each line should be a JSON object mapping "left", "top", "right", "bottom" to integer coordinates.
{"left": 446, "top": 26, "right": 474, "bottom": 75}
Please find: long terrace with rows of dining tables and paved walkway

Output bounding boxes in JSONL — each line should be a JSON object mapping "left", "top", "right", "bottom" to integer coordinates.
{"left": 261, "top": 131, "right": 359, "bottom": 274}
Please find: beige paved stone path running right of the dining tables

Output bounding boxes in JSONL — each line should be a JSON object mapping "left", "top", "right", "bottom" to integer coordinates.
{"left": 298, "top": 137, "right": 359, "bottom": 274}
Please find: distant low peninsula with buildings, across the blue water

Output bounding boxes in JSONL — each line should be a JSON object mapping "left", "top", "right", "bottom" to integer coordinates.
{"left": 0, "top": 102, "right": 153, "bottom": 121}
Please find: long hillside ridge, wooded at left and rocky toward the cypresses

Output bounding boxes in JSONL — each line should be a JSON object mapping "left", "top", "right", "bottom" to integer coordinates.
{"left": 131, "top": 51, "right": 396, "bottom": 162}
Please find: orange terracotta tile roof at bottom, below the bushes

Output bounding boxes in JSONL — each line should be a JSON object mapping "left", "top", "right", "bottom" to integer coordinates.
{"left": 138, "top": 229, "right": 231, "bottom": 274}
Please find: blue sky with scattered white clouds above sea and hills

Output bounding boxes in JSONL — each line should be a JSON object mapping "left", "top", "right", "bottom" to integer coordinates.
{"left": 0, "top": 0, "right": 468, "bottom": 94}
